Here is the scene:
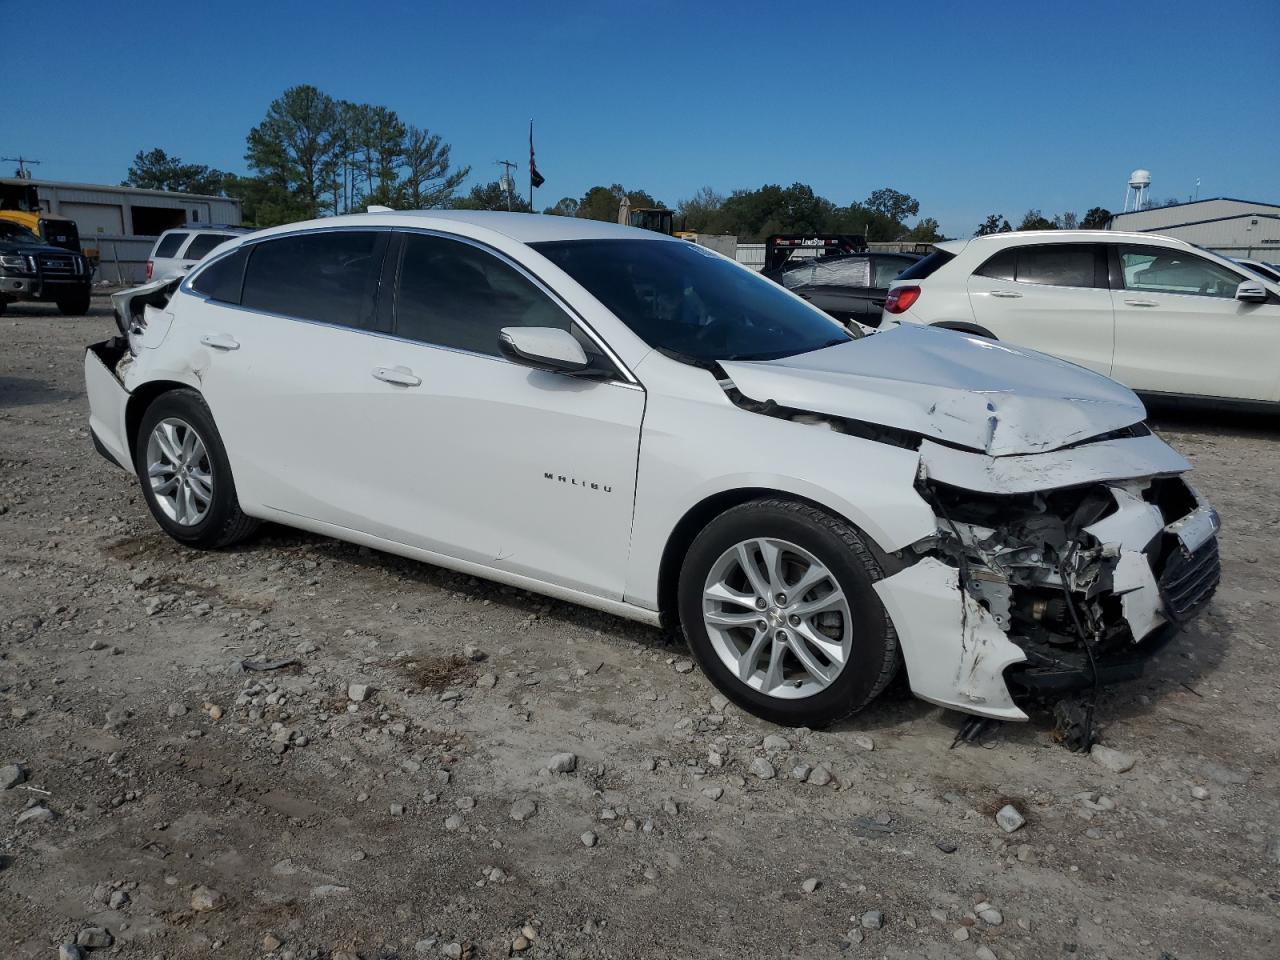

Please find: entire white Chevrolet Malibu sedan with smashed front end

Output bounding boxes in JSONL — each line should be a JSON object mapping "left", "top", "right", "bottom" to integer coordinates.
{"left": 84, "top": 211, "right": 1219, "bottom": 724}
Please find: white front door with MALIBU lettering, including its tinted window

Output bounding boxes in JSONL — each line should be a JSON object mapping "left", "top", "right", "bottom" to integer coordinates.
{"left": 351, "top": 233, "right": 645, "bottom": 599}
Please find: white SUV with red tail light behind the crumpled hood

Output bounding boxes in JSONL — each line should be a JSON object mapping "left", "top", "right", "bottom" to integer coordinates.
{"left": 883, "top": 230, "right": 1280, "bottom": 410}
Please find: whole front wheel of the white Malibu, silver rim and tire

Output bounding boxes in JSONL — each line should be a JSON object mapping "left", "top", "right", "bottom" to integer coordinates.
{"left": 678, "top": 499, "right": 899, "bottom": 727}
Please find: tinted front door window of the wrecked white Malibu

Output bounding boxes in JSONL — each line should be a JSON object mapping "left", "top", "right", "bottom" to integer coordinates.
{"left": 396, "top": 234, "right": 573, "bottom": 357}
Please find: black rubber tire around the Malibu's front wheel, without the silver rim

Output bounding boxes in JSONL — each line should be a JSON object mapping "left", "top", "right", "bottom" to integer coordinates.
{"left": 678, "top": 502, "right": 897, "bottom": 726}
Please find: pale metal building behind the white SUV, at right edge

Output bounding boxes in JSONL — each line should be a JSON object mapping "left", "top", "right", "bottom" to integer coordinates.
{"left": 1111, "top": 197, "right": 1280, "bottom": 264}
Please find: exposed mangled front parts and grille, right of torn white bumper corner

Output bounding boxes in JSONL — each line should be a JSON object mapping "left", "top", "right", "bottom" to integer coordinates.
{"left": 913, "top": 477, "right": 1219, "bottom": 690}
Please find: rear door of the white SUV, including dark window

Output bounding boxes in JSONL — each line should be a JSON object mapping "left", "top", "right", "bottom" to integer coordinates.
{"left": 966, "top": 243, "right": 1115, "bottom": 375}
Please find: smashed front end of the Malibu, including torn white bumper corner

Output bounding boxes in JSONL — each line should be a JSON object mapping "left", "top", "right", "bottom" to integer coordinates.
{"left": 881, "top": 465, "right": 1220, "bottom": 719}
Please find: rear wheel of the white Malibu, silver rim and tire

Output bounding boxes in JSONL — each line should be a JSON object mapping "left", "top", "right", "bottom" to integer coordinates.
{"left": 134, "top": 389, "right": 259, "bottom": 549}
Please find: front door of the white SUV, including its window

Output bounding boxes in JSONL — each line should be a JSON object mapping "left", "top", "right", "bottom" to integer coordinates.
{"left": 1112, "top": 243, "right": 1280, "bottom": 401}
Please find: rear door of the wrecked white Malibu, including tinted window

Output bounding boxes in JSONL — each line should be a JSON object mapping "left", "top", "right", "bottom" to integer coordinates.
{"left": 184, "top": 230, "right": 389, "bottom": 530}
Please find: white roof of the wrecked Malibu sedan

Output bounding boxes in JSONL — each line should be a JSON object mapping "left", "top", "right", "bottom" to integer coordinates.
{"left": 240, "top": 210, "right": 687, "bottom": 243}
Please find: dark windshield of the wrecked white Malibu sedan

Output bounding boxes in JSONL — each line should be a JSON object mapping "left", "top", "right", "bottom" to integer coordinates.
{"left": 531, "top": 239, "right": 854, "bottom": 365}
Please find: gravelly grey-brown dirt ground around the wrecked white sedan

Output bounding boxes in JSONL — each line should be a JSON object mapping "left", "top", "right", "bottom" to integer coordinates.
{"left": 0, "top": 300, "right": 1280, "bottom": 960}
